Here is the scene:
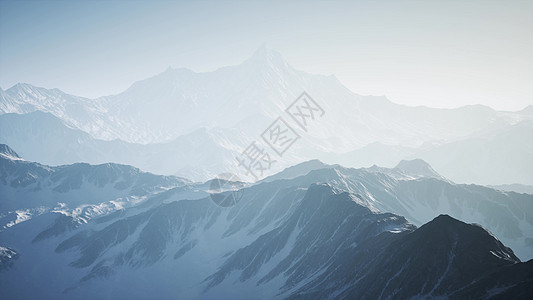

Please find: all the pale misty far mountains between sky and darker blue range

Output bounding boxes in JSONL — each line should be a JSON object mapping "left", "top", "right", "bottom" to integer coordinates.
{"left": 0, "top": 47, "right": 533, "bottom": 185}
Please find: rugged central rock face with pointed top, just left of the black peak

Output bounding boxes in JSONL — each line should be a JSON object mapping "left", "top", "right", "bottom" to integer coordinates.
{"left": 204, "top": 186, "right": 414, "bottom": 291}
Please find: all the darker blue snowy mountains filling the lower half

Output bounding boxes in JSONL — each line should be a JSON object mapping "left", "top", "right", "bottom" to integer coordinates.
{"left": 0, "top": 145, "right": 533, "bottom": 299}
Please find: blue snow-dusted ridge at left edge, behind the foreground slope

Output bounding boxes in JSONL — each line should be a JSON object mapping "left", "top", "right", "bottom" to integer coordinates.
{"left": 0, "top": 144, "right": 190, "bottom": 231}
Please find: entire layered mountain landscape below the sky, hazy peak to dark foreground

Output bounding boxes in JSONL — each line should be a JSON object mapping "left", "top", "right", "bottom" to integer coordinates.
{"left": 0, "top": 47, "right": 533, "bottom": 299}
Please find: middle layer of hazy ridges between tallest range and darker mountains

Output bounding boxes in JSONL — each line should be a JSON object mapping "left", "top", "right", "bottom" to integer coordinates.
{"left": 0, "top": 106, "right": 533, "bottom": 184}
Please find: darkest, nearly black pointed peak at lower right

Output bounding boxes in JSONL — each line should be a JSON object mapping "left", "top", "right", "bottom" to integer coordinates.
{"left": 295, "top": 215, "right": 520, "bottom": 299}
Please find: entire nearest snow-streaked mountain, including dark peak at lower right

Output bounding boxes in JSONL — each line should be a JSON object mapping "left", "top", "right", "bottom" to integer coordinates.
{"left": 0, "top": 173, "right": 530, "bottom": 299}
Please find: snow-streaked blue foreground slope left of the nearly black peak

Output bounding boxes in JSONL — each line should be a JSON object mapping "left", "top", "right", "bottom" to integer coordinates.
{"left": 0, "top": 182, "right": 415, "bottom": 298}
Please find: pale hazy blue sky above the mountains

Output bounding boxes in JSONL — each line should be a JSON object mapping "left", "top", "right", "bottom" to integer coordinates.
{"left": 0, "top": 0, "right": 533, "bottom": 110}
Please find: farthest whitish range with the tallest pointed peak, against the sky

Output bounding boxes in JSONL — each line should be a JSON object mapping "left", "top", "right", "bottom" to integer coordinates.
{"left": 0, "top": 47, "right": 532, "bottom": 147}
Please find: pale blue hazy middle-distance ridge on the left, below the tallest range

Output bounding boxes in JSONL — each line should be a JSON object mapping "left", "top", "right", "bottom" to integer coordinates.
{"left": 0, "top": 111, "right": 245, "bottom": 181}
